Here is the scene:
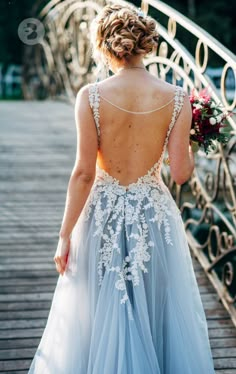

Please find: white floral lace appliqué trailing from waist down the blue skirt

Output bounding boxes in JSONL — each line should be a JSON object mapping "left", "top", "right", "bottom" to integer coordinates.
{"left": 85, "top": 174, "right": 180, "bottom": 304}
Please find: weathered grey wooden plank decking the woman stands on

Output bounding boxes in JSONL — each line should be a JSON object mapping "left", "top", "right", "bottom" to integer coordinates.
{"left": 0, "top": 101, "right": 236, "bottom": 374}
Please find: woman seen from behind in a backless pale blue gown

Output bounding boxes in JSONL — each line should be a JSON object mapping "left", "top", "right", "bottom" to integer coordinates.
{"left": 29, "top": 5, "right": 214, "bottom": 374}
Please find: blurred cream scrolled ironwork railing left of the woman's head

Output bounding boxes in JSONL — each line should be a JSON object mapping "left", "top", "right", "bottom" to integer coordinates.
{"left": 23, "top": 0, "right": 104, "bottom": 102}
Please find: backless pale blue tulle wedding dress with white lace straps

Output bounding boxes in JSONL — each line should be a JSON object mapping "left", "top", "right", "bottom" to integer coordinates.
{"left": 29, "top": 84, "right": 214, "bottom": 374}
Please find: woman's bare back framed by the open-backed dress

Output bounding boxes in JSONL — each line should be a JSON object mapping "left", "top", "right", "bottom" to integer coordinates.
{"left": 89, "top": 71, "right": 185, "bottom": 185}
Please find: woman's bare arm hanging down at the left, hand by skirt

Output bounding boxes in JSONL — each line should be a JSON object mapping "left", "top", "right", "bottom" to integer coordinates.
{"left": 54, "top": 86, "right": 98, "bottom": 275}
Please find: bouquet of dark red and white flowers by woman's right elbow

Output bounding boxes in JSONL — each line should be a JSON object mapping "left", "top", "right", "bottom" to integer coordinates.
{"left": 189, "top": 89, "right": 228, "bottom": 154}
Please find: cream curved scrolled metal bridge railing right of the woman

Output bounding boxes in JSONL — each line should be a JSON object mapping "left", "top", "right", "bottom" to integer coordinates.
{"left": 138, "top": 0, "right": 236, "bottom": 324}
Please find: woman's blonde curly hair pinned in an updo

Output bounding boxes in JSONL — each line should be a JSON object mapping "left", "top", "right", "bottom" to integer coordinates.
{"left": 91, "top": 4, "right": 159, "bottom": 60}
